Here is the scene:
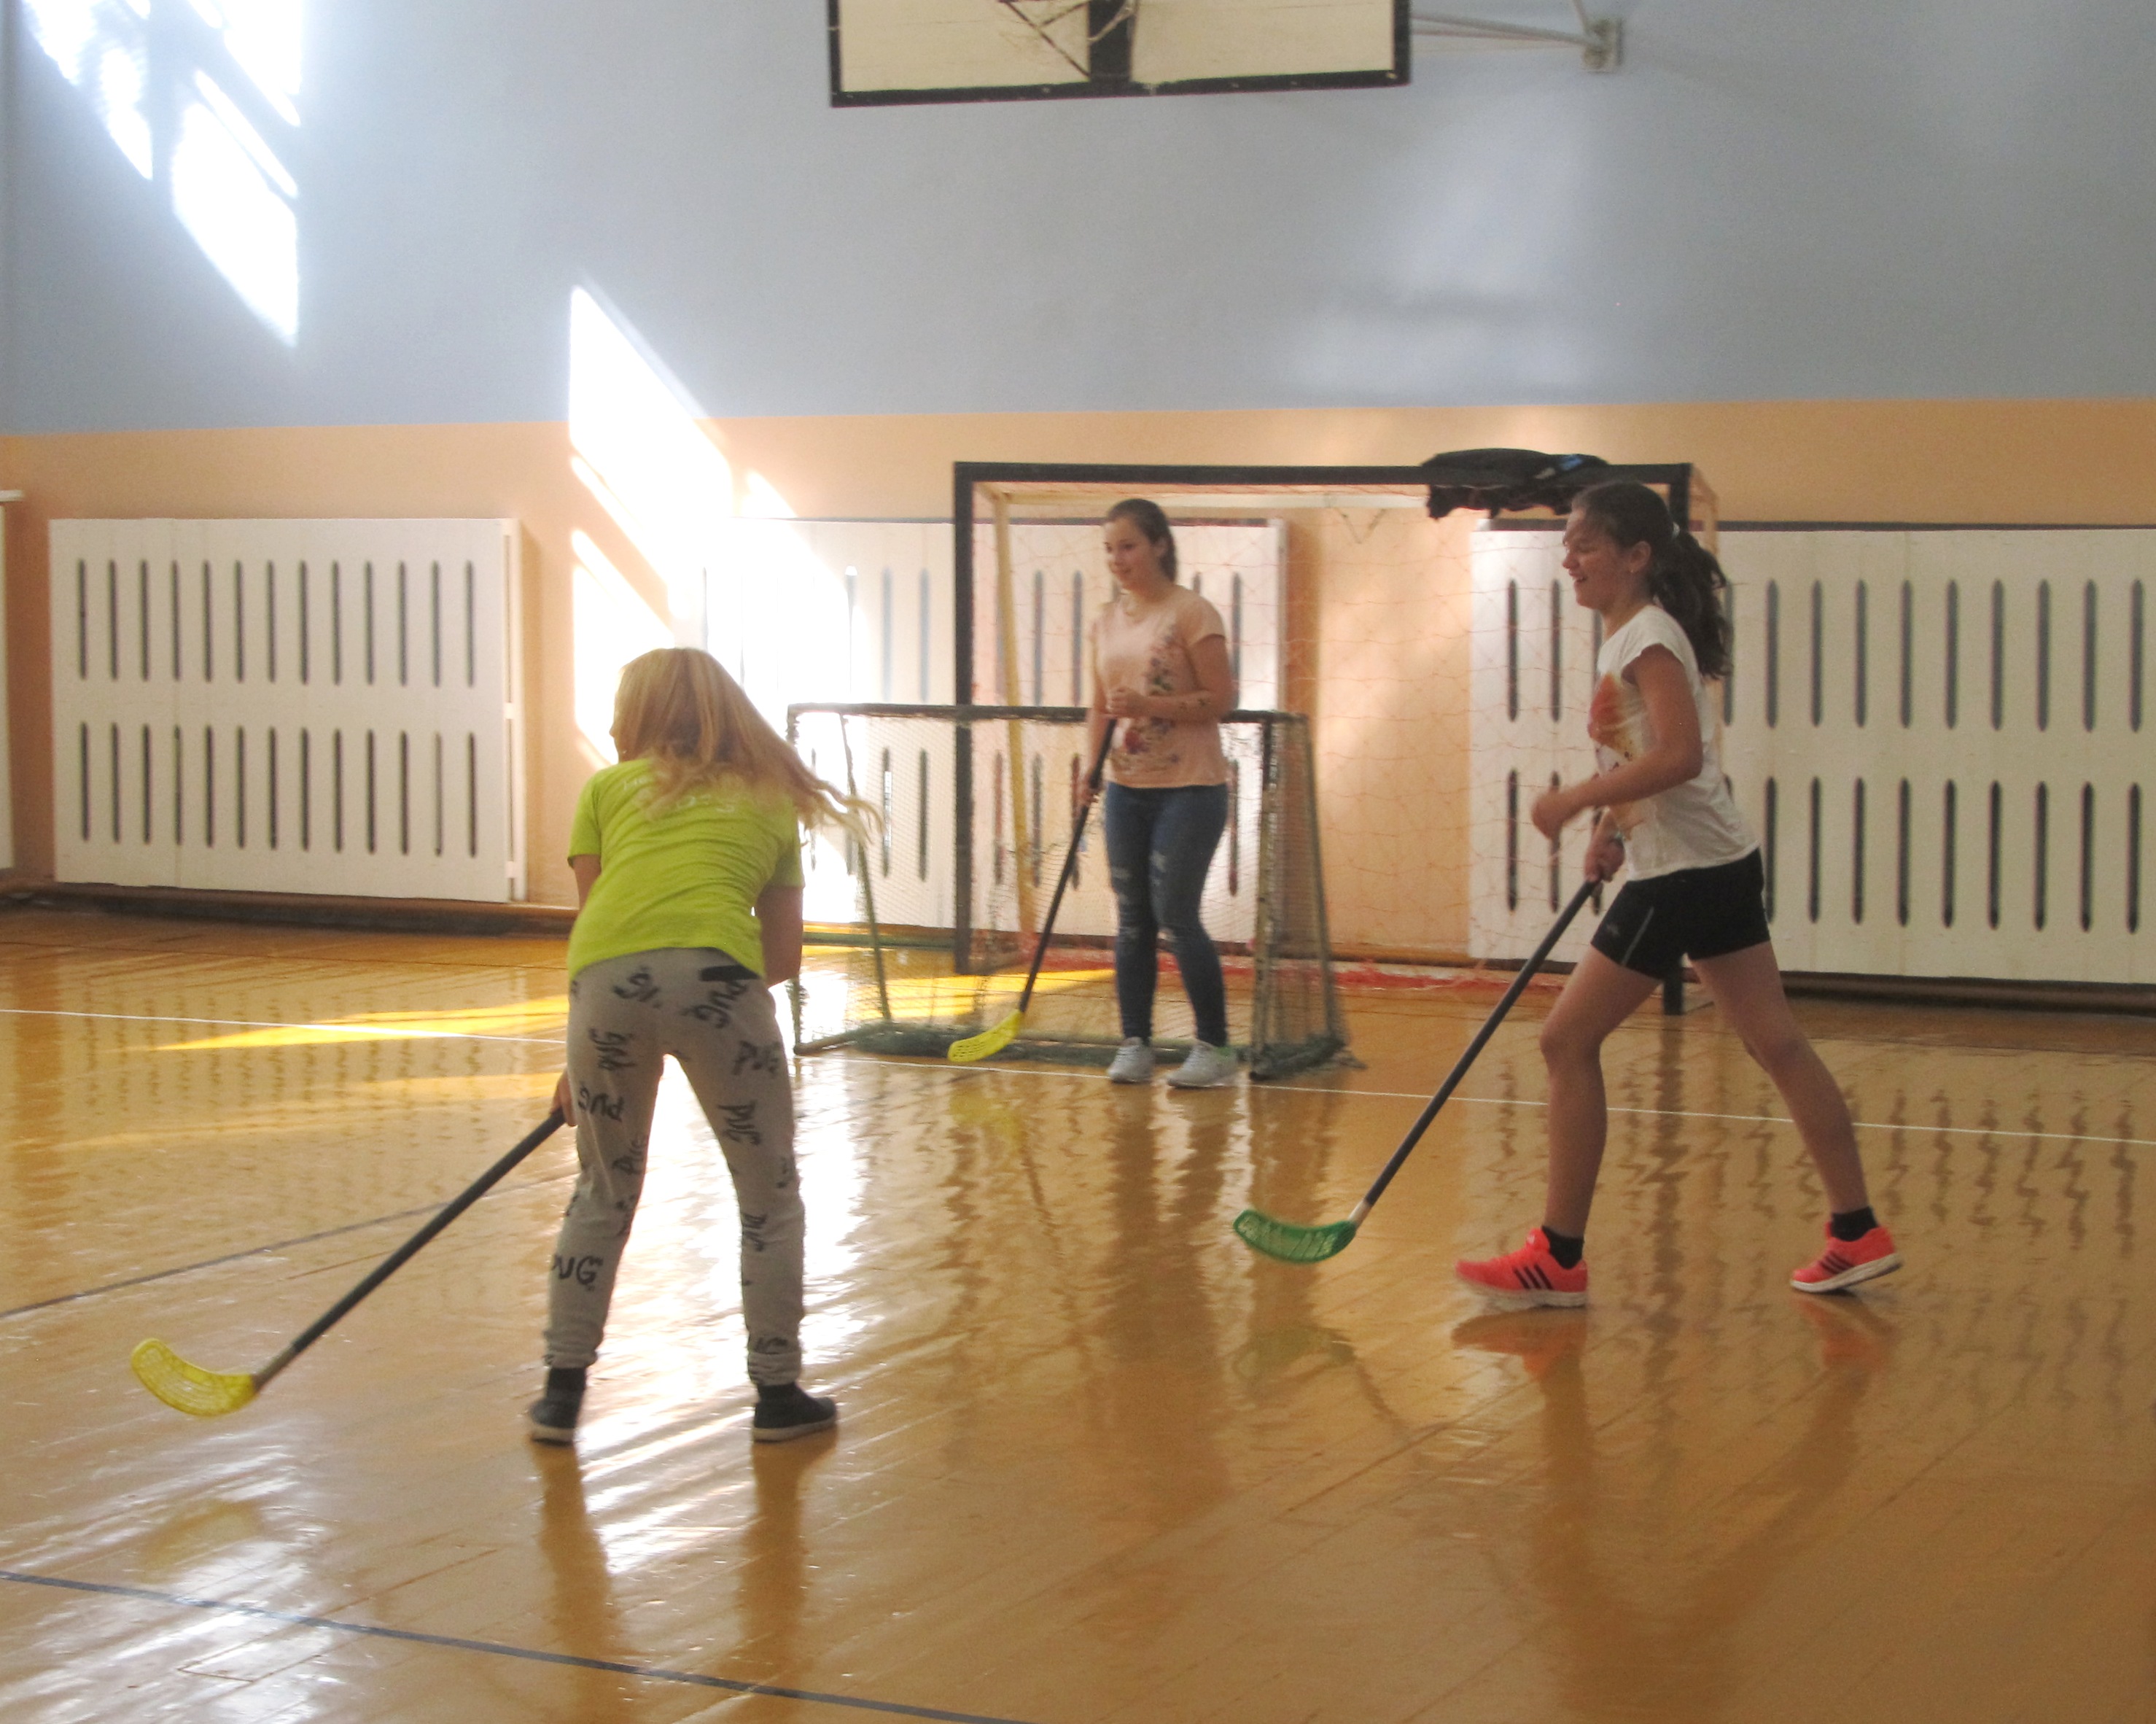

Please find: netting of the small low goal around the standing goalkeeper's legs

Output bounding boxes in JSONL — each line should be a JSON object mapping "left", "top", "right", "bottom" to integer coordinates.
{"left": 789, "top": 705, "right": 1347, "bottom": 1076}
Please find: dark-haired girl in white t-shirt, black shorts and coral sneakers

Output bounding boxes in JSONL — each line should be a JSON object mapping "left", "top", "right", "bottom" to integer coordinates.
{"left": 1458, "top": 484, "right": 1902, "bottom": 1305}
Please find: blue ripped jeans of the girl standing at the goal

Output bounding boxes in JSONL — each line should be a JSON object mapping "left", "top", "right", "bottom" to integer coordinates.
{"left": 1102, "top": 783, "right": 1227, "bottom": 1047}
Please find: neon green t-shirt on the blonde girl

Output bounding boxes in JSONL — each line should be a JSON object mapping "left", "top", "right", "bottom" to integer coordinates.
{"left": 569, "top": 759, "right": 802, "bottom": 975}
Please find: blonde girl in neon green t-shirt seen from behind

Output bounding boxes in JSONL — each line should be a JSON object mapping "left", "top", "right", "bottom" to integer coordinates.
{"left": 530, "top": 648, "right": 865, "bottom": 1443}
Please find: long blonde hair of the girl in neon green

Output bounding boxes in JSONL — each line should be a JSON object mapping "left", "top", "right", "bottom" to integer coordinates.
{"left": 615, "top": 648, "right": 876, "bottom": 837}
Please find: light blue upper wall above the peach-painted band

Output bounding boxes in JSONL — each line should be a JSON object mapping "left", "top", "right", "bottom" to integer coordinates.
{"left": 0, "top": 0, "right": 2156, "bottom": 432}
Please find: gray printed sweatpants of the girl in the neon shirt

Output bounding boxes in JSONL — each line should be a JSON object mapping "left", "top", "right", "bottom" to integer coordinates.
{"left": 545, "top": 947, "right": 802, "bottom": 1383}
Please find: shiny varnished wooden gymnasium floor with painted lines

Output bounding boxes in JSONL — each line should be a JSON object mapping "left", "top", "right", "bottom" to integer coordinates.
{"left": 0, "top": 911, "right": 2156, "bottom": 1724}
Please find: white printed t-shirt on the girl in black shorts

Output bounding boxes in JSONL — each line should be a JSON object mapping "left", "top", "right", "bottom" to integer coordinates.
{"left": 1587, "top": 604, "right": 1759, "bottom": 880}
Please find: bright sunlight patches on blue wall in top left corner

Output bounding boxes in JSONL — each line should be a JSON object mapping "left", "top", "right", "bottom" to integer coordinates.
{"left": 24, "top": 0, "right": 300, "bottom": 345}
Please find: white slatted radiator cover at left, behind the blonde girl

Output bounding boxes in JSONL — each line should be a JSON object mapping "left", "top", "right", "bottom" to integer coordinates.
{"left": 52, "top": 520, "right": 524, "bottom": 902}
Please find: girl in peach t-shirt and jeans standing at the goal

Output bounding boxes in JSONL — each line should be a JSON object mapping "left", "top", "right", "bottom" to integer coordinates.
{"left": 1089, "top": 497, "right": 1235, "bottom": 1090}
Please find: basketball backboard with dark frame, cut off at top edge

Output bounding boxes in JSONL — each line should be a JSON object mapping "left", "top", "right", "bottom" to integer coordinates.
{"left": 828, "top": 0, "right": 1408, "bottom": 108}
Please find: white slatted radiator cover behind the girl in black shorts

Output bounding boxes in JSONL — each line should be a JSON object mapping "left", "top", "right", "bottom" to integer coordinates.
{"left": 1473, "top": 529, "right": 2156, "bottom": 986}
